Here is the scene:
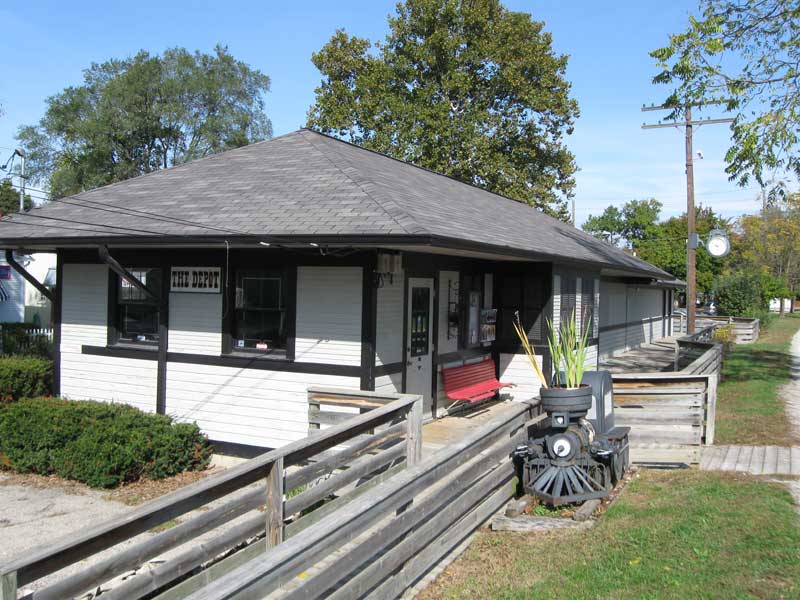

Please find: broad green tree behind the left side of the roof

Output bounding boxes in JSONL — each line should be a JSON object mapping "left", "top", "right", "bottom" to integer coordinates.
{"left": 17, "top": 46, "right": 272, "bottom": 198}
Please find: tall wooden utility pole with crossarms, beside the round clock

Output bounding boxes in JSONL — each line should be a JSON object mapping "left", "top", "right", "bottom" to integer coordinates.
{"left": 642, "top": 104, "right": 733, "bottom": 335}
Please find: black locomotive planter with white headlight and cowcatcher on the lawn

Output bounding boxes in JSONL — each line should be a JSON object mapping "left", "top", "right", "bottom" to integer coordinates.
{"left": 515, "top": 385, "right": 630, "bottom": 506}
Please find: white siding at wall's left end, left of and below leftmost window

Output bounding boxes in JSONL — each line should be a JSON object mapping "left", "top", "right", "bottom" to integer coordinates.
{"left": 61, "top": 264, "right": 158, "bottom": 412}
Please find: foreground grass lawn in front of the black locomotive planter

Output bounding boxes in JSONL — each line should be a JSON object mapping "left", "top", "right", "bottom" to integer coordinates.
{"left": 419, "top": 470, "right": 800, "bottom": 600}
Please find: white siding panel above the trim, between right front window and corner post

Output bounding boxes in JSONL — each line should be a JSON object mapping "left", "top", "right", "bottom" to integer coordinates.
{"left": 295, "top": 267, "right": 362, "bottom": 366}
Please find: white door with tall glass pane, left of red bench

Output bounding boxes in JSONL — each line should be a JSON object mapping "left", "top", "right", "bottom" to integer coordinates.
{"left": 406, "top": 277, "right": 434, "bottom": 416}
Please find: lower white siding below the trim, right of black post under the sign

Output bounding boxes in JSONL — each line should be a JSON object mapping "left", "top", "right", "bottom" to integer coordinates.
{"left": 166, "top": 363, "right": 360, "bottom": 448}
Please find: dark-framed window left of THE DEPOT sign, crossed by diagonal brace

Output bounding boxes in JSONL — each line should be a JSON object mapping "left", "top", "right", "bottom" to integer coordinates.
{"left": 117, "top": 268, "right": 161, "bottom": 344}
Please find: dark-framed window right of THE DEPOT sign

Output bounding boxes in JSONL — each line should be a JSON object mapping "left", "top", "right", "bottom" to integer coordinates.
{"left": 233, "top": 269, "right": 288, "bottom": 353}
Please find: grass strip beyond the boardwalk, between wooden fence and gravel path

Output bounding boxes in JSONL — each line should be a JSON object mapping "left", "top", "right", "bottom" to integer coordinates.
{"left": 714, "top": 315, "right": 800, "bottom": 446}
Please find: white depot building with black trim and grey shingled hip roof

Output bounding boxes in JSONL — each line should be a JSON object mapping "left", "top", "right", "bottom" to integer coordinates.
{"left": 0, "top": 130, "right": 672, "bottom": 452}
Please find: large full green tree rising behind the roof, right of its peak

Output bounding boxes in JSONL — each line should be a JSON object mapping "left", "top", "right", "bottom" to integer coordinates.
{"left": 308, "top": 0, "right": 578, "bottom": 220}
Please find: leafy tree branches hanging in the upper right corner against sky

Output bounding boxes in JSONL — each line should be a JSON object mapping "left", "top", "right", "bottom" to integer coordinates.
{"left": 651, "top": 0, "right": 800, "bottom": 190}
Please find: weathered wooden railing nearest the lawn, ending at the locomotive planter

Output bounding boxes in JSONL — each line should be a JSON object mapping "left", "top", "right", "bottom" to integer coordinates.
{"left": 183, "top": 403, "right": 545, "bottom": 600}
